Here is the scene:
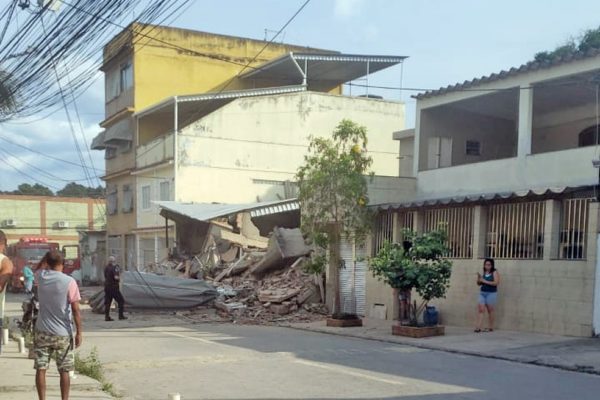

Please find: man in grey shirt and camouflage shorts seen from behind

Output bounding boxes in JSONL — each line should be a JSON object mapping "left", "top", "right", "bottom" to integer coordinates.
{"left": 33, "top": 250, "right": 83, "bottom": 400}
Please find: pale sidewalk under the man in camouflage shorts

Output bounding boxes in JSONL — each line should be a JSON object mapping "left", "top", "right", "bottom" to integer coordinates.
{"left": 0, "top": 341, "right": 112, "bottom": 400}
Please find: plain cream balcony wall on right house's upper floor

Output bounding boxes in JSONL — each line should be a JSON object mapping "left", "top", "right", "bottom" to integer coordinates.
{"left": 417, "top": 147, "right": 598, "bottom": 199}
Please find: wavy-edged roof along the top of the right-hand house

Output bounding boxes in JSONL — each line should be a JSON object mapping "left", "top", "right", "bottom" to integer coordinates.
{"left": 413, "top": 49, "right": 600, "bottom": 100}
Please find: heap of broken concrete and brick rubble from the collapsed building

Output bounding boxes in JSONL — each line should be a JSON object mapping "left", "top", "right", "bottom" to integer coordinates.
{"left": 140, "top": 228, "right": 327, "bottom": 324}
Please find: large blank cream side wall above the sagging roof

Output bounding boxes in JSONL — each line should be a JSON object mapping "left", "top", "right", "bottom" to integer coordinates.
{"left": 177, "top": 92, "right": 404, "bottom": 203}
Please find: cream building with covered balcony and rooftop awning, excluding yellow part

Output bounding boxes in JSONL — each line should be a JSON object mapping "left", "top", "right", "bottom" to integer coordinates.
{"left": 131, "top": 54, "right": 414, "bottom": 267}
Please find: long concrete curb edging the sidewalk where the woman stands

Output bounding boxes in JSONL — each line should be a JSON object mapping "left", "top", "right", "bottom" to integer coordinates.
{"left": 280, "top": 325, "right": 600, "bottom": 375}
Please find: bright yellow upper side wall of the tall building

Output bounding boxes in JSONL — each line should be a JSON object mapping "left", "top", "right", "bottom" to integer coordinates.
{"left": 133, "top": 27, "right": 332, "bottom": 110}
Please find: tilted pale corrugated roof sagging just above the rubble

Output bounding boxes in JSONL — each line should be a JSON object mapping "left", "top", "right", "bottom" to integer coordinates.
{"left": 154, "top": 199, "right": 300, "bottom": 222}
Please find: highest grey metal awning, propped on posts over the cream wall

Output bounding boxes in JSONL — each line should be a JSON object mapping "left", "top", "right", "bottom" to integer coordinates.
{"left": 240, "top": 53, "right": 407, "bottom": 88}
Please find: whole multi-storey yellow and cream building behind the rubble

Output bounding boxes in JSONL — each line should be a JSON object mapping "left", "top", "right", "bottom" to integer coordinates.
{"left": 92, "top": 26, "right": 405, "bottom": 267}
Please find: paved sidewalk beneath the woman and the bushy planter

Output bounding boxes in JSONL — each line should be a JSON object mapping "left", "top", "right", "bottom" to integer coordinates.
{"left": 288, "top": 318, "right": 600, "bottom": 374}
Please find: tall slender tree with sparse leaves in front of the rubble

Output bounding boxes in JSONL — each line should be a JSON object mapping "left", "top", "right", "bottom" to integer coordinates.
{"left": 297, "top": 119, "right": 373, "bottom": 317}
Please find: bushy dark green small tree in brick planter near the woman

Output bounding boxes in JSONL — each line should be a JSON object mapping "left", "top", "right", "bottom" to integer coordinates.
{"left": 370, "top": 229, "right": 452, "bottom": 337}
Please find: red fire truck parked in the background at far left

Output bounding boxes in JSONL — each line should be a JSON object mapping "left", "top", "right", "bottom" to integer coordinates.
{"left": 7, "top": 237, "right": 81, "bottom": 291}
